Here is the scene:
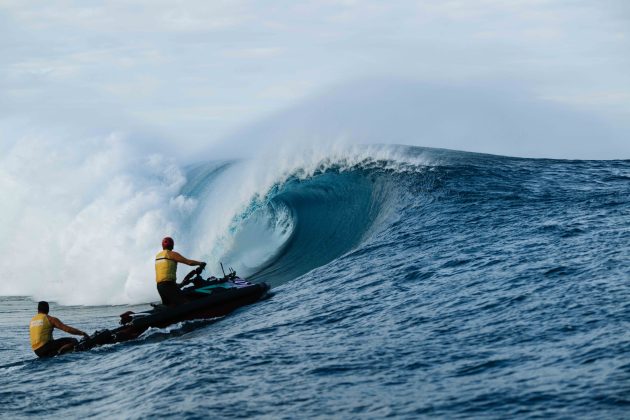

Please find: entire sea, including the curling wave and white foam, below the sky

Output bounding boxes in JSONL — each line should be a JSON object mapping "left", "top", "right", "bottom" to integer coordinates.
{"left": 0, "top": 140, "right": 630, "bottom": 418}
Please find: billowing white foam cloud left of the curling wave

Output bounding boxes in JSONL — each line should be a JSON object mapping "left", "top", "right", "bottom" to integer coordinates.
{"left": 0, "top": 130, "right": 196, "bottom": 304}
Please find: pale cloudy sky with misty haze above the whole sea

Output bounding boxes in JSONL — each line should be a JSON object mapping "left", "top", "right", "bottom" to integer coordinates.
{"left": 0, "top": 0, "right": 630, "bottom": 159}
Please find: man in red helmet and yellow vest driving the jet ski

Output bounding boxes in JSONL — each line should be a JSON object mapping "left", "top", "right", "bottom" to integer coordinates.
{"left": 155, "top": 236, "right": 206, "bottom": 306}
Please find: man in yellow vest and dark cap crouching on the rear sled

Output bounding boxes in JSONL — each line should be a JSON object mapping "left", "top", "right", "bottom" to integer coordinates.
{"left": 29, "top": 301, "right": 88, "bottom": 357}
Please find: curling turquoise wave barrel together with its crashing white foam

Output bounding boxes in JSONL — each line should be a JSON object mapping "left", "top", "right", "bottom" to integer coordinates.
{"left": 0, "top": 135, "right": 434, "bottom": 305}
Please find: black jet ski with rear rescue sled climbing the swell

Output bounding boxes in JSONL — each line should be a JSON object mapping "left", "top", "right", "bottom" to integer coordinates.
{"left": 75, "top": 267, "right": 270, "bottom": 351}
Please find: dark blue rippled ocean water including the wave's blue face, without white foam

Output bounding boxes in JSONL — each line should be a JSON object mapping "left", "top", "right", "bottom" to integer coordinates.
{"left": 0, "top": 148, "right": 630, "bottom": 419}
